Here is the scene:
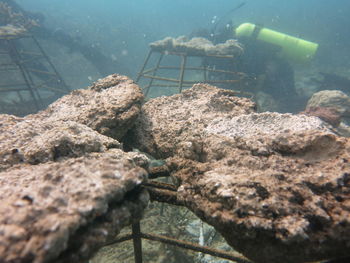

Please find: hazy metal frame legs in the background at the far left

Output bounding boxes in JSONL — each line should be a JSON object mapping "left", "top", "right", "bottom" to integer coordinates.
{"left": 0, "top": 30, "right": 70, "bottom": 112}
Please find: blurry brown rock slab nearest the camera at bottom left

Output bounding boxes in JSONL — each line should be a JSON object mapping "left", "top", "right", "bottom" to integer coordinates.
{"left": 0, "top": 149, "right": 148, "bottom": 263}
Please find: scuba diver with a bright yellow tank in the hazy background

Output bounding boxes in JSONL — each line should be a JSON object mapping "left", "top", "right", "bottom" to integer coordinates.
{"left": 194, "top": 3, "right": 317, "bottom": 112}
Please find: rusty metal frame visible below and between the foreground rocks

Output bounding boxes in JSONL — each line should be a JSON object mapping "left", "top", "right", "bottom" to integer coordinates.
{"left": 106, "top": 166, "right": 252, "bottom": 263}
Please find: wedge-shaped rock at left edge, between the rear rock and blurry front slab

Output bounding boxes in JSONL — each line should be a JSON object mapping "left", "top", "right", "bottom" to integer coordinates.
{"left": 0, "top": 115, "right": 120, "bottom": 171}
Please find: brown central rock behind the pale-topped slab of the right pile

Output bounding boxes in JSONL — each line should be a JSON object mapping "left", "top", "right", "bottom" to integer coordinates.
{"left": 127, "top": 84, "right": 255, "bottom": 158}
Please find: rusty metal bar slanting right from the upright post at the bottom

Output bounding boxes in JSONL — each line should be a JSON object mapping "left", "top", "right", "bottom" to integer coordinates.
{"left": 141, "top": 233, "right": 252, "bottom": 263}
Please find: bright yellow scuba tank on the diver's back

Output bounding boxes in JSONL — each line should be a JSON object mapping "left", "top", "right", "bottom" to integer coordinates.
{"left": 235, "top": 23, "right": 318, "bottom": 63}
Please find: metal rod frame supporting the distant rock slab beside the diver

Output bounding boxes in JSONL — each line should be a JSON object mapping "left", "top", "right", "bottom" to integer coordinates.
{"left": 136, "top": 48, "right": 245, "bottom": 96}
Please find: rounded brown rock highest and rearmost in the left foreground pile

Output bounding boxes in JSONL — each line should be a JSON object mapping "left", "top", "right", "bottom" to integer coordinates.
{"left": 40, "top": 74, "right": 143, "bottom": 140}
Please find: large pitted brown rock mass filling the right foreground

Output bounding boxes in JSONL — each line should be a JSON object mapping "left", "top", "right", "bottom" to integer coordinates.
{"left": 128, "top": 84, "right": 350, "bottom": 263}
